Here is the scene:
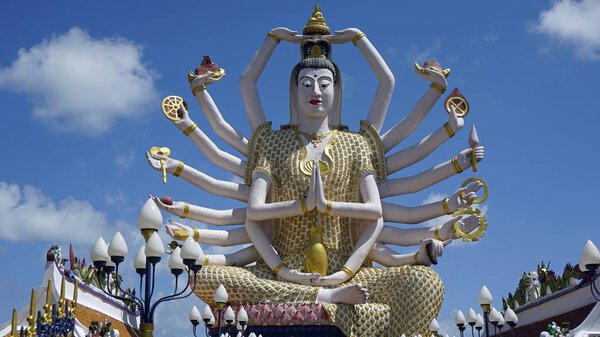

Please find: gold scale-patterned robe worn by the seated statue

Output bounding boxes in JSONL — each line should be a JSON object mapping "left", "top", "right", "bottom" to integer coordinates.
{"left": 196, "top": 122, "right": 444, "bottom": 337}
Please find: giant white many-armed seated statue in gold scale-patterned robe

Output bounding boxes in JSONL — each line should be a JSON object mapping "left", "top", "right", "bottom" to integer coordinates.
{"left": 147, "top": 6, "right": 485, "bottom": 336}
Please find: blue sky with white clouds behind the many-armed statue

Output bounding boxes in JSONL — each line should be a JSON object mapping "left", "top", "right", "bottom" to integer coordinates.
{"left": 0, "top": 0, "right": 600, "bottom": 336}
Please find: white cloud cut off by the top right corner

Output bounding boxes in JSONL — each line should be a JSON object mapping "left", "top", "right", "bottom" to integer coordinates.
{"left": 532, "top": 0, "right": 600, "bottom": 60}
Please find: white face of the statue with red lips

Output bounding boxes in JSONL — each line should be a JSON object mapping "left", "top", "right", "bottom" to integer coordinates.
{"left": 296, "top": 68, "right": 335, "bottom": 118}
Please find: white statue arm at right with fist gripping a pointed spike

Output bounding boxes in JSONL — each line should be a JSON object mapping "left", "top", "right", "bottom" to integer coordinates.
{"left": 379, "top": 146, "right": 484, "bottom": 198}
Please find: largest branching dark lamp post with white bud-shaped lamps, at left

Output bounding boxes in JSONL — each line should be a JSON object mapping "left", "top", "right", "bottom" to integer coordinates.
{"left": 91, "top": 199, "right": 204, "bottom": 337}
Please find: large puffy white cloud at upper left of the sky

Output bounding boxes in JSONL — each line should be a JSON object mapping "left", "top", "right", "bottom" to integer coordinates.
{"left": 0, "top": 27, "right": 157, "bottom": 136}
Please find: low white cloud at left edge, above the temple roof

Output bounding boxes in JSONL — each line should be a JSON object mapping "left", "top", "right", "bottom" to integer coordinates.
{"left": 0, "top": 182, "right": 110, "bottom": 244}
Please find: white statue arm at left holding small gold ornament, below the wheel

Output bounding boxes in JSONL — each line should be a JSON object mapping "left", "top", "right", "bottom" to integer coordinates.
{"left": 146, "top": 152, "right": 250, "bottom": 202}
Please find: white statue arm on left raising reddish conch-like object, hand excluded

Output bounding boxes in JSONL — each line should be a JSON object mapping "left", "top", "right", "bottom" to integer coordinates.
{"left": 190, "top": 86, "right": 248, "bottom": 155}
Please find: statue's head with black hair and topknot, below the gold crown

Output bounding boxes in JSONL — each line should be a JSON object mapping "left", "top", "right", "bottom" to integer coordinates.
{"left": 290, "top": 38, "right": 342, "bottom": 128}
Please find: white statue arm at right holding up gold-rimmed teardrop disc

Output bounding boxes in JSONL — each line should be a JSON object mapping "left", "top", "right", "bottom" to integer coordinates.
{"left": 386, "top": 105, "right": 464, "bottom": 174}
